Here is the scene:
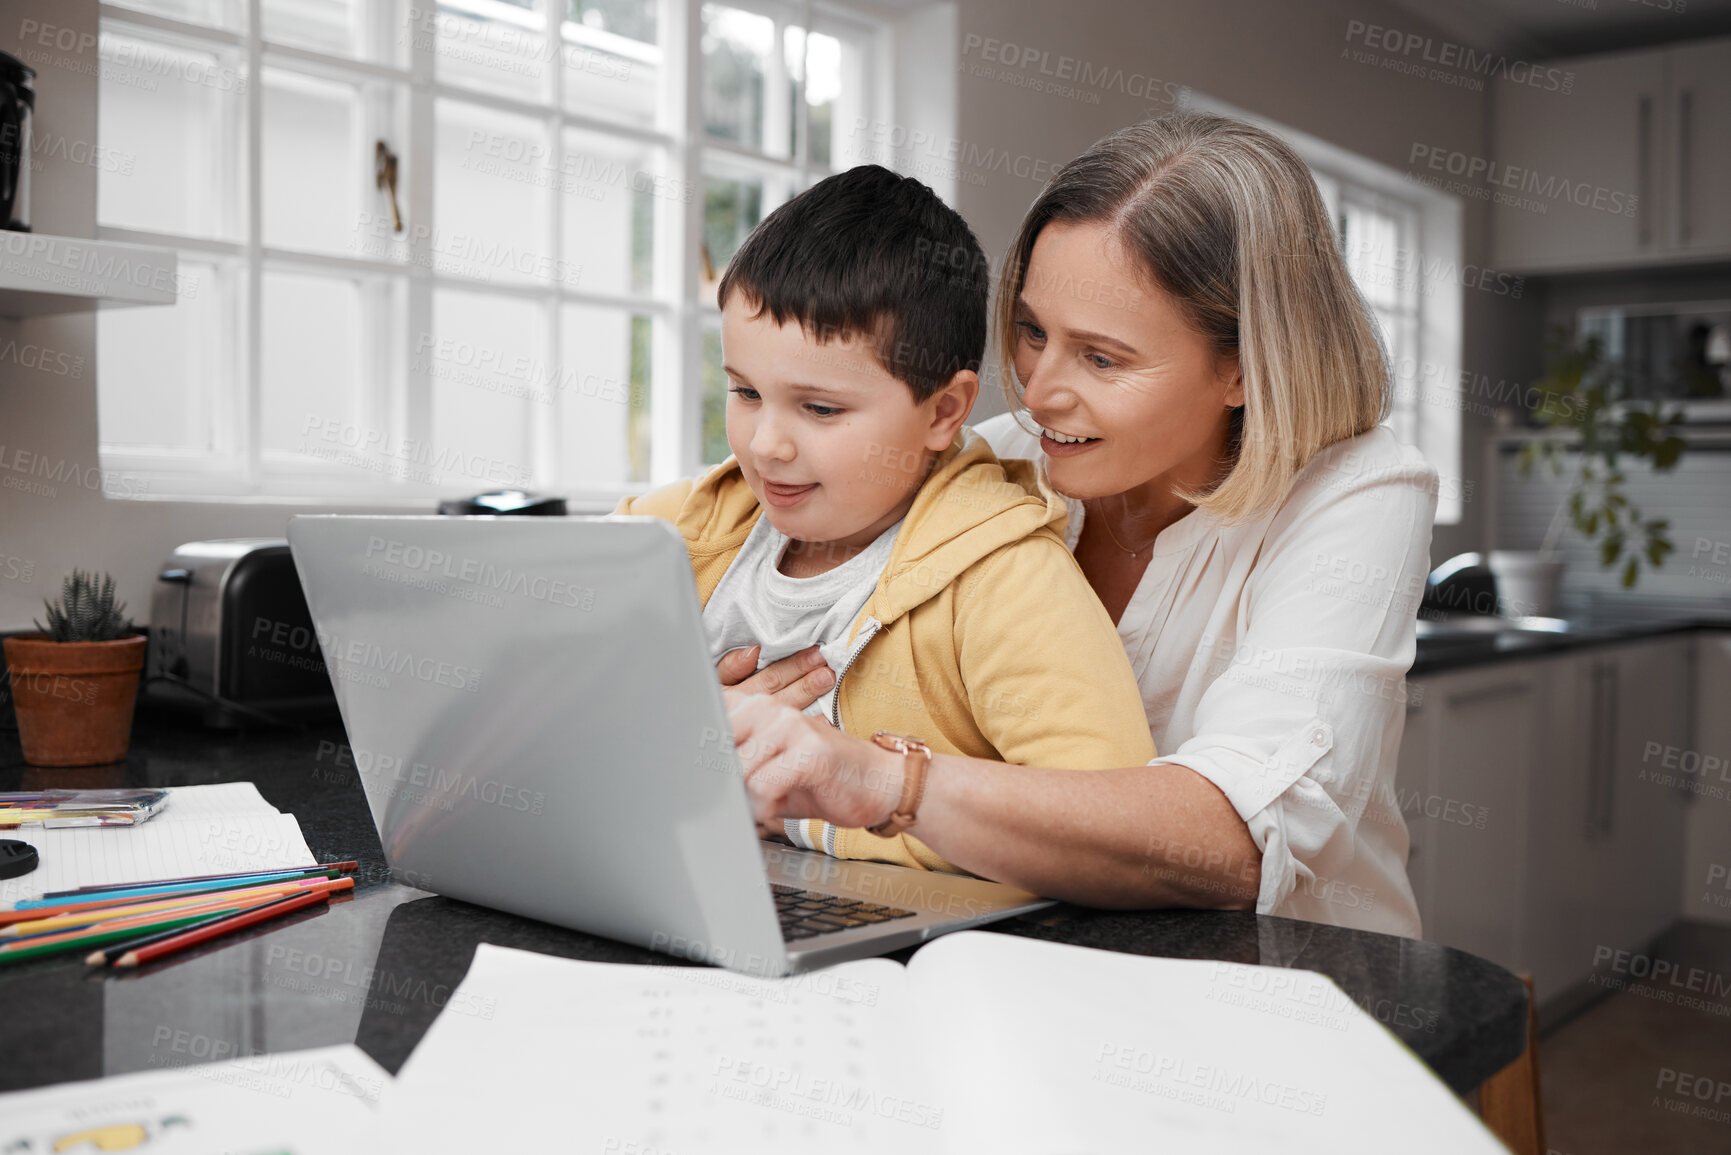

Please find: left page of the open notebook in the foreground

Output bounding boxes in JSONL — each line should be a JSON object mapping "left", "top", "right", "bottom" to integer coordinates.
{"left": 384, "top": 944, "right": 942, "bottom": 1155}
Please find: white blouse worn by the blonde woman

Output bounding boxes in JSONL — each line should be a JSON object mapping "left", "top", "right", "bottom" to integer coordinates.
{"left": 976, "top": 414, "right": 1437, "bottom": 939}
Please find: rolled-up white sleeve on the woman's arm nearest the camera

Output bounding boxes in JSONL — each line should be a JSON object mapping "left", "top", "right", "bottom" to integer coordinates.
{"left": 1155, "top": 454, "right": 1437, "bottom": 933}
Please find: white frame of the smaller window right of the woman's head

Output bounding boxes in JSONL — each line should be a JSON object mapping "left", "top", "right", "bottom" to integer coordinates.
{"left": 1179, "top": 88, "right": 1466, "bottom": 525}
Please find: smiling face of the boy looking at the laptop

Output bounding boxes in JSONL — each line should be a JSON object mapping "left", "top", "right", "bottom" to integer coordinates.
{"left": 722, "top": 293, "right": 978, "bottom": 565}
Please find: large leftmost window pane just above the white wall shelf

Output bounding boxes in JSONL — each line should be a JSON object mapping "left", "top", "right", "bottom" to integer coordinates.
{"left": 97, "top": 26, "right": 246, "bottom": 241}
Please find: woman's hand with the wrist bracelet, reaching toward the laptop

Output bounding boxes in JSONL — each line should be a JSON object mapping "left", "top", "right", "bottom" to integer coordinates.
{"left": 725, "top": 691, "right": 902, "bottom": 826}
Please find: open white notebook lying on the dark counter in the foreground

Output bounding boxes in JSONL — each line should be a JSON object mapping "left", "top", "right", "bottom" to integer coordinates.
{"left": 384, "top": 932, "right": 1503, "bottom": 1155}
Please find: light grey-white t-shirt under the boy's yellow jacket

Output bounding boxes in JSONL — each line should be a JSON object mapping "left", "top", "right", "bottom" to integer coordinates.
{"left": 703, "top": 516, "right": 902, "bottom": 719}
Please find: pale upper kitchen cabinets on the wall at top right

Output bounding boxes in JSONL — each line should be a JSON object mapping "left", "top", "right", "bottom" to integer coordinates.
{"left": 1488, "top": 40, "right": 1731, "bottom": 274}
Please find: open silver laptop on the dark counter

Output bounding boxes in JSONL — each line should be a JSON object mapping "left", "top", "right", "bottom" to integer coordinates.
{"left": 289, "top": 516, "right": 1049, "bottom": 975}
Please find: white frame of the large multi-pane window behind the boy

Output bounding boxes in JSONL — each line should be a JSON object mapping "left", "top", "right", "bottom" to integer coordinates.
{"left": 97, "top": 0, "right": 893, "bottom": 511}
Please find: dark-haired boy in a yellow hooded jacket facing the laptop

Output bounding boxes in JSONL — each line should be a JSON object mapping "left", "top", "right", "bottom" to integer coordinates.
{"left": 616, "top": 165, "right": 1155, "bottom": 871}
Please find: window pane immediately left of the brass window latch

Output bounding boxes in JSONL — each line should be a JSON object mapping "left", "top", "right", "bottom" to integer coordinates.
{"left": 261, "top": 68, "right": 362, "bottom": 253}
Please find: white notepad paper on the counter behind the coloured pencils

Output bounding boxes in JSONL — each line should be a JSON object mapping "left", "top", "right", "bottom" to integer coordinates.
{"left": 0, "top": 783, "right": 315, "bottom": 907}
